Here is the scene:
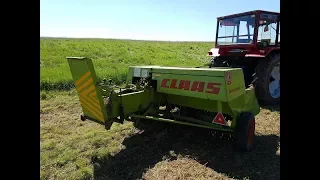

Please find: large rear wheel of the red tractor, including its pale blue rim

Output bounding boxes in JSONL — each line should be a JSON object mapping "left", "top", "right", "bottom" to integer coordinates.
{"left": 255, "top": 53, "right": 280, "bottom": 105}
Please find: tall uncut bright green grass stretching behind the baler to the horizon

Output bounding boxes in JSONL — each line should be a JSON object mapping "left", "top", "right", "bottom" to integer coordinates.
{"left": 40, "top": 38, "right": 214, "bottom": 90}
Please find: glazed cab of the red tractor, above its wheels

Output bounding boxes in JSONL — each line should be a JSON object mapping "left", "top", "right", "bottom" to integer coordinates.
{"left": 208, "top": 10, "right": 280, "bottom": 57}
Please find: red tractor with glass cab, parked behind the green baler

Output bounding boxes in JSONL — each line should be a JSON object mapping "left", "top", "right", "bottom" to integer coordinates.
{"left": 208, "top": 10, "right": 280, "bottom": 105}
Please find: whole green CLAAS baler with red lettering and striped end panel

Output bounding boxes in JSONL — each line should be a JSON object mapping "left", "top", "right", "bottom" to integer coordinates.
{"left": 67, "top": 57, "right": 260, "bottom": 151}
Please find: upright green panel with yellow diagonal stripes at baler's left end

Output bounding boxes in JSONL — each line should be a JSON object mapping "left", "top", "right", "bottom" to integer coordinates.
{"left": 67, "top": 57, "right": 108, "bottom": 123}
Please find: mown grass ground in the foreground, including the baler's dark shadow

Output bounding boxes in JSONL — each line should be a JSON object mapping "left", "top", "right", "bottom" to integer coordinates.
{"left": 40, "top": 90, "right": 280, "bottom": 180}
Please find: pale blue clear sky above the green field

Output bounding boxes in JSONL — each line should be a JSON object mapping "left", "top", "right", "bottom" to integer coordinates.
{"left": 40, "top": 0, "right": 280, "bottom": 41}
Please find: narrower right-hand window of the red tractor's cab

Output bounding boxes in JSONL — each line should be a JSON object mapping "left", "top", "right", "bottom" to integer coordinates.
{"left": 258, "top": 13, "right": 280, "bottom": 45}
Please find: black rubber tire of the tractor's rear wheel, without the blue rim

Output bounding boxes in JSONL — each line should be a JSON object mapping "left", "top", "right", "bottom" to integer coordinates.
{"left": 255, "top": 53, "right": 280, "bottom": 106}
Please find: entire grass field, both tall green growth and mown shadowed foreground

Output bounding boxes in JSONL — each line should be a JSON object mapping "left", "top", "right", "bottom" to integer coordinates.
{"left": 40, "top": 38, "right": 280, "bottom": 180}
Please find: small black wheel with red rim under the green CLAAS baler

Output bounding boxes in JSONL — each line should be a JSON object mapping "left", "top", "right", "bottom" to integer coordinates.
{"left": 233, "top": 112, "right": 255, "bottom": 152}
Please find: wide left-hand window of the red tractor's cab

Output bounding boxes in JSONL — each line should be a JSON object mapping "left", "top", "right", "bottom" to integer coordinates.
{"left": 217, "top": 14, "right": 255, "bottom": 45}
